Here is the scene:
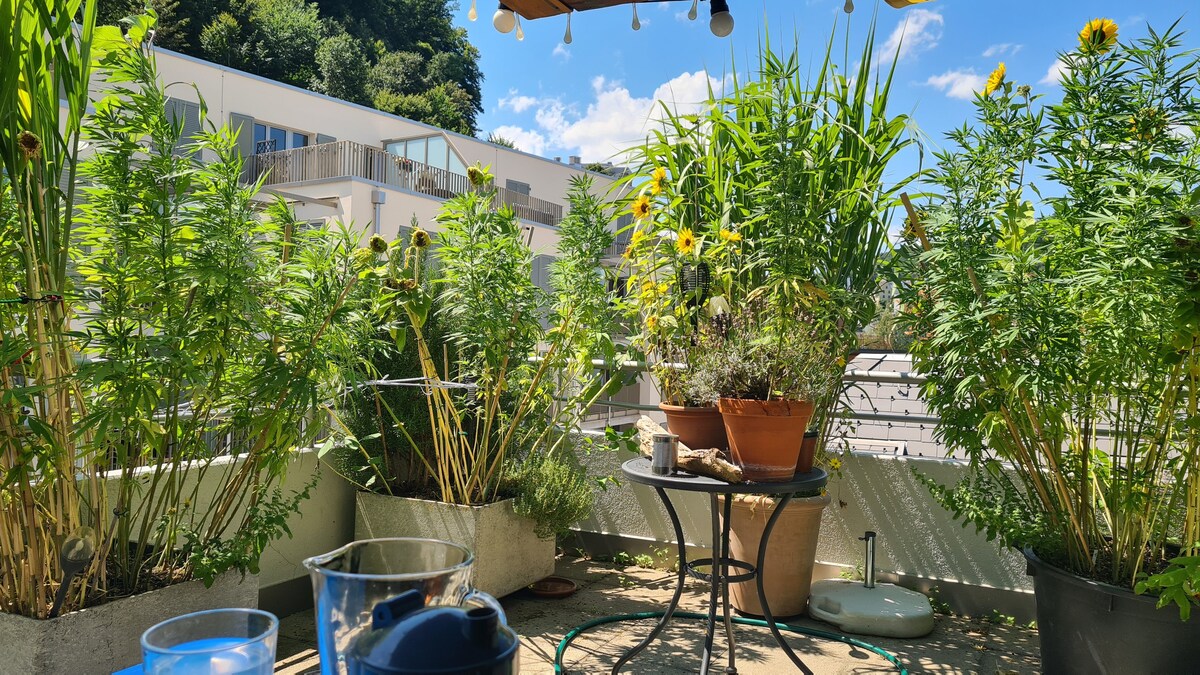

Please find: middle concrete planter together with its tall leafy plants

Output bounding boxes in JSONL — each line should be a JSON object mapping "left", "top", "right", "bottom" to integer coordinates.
{"left": 324, "top": 166, "right": 624, "bottom": 596}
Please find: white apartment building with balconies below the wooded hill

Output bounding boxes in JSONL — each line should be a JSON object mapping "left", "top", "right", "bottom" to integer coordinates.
{"left": 156, "top": 49, "right": 614, "bottom": 257}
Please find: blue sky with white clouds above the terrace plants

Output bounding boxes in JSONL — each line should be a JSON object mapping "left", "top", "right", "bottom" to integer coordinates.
{"left": 456, "top": 0, "right": 1200, "bottom": 166}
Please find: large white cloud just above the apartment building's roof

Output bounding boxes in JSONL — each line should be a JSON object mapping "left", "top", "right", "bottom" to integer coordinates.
{"left": 496, "top": 71, "right": 722, "bottom": 162}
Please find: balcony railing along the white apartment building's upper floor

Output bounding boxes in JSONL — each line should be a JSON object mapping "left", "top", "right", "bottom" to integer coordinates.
{"left": 248, "top": 141, "right": 563, "bottom": 226}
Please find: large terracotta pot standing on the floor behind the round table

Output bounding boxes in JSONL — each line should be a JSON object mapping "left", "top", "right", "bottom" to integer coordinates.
{"left": 721, "top": 487, "right": 829, "bottom": 620}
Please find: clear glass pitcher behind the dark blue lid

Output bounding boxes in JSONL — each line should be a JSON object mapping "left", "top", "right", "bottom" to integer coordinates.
{"left": 304, "top": 538, "right": 506, "bottom": 675}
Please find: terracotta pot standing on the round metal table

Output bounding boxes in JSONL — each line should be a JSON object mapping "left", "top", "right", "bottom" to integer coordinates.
{"left": 716, "top": 399, "right": 812, "bottom": 483}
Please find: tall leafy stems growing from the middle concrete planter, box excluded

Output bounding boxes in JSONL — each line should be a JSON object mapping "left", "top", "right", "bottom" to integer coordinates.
{"left": 324, "top": 166, "right": 625, "bottom": 536}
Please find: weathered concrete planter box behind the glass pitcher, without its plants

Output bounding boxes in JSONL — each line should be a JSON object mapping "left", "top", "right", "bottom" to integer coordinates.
{"left": 354, "top": 492, "right": 554, "bottom": 597}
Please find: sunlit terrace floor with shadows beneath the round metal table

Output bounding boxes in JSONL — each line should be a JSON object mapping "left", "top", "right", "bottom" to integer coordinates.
{"left": 276, "top": 557, "right": 1039, "bottom": 675}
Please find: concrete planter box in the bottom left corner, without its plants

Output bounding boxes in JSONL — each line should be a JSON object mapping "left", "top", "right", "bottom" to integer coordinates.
{"left": 0, "top": 566, "right": 258, "bottom": 675}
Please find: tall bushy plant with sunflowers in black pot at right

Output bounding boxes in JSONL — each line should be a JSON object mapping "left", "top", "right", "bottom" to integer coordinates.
{"left": 894, "top": 19, "right": 1200, "bottom": 673}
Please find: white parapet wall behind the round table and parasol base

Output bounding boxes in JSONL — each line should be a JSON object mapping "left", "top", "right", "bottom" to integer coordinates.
{"left": 577, "top": 444, "right": 1032, "bottom": 619}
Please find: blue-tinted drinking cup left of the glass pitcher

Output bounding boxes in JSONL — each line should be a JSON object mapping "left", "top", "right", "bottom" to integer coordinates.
{"left": 142, "top": 608, "right": 280, "bottom": 675}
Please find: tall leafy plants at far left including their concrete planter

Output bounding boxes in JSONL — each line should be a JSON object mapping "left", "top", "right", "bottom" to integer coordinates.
{"left": 0, "top": 10, "right": 365, "bottom": 673}
